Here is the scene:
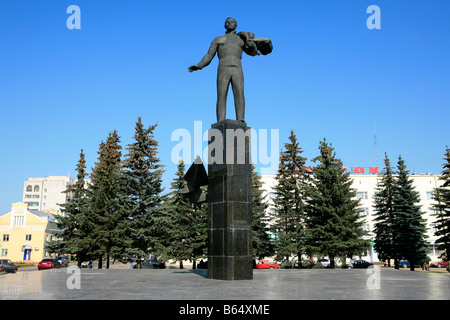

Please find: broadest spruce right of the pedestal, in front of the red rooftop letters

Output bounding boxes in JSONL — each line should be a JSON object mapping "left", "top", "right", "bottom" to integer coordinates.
{"left": 306, "top": 139, "right": 369, "bottom": 268}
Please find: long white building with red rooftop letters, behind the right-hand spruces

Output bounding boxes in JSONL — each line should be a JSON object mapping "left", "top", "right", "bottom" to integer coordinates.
{"left": 261, "top": 168, "right": 442, "bottom": 261}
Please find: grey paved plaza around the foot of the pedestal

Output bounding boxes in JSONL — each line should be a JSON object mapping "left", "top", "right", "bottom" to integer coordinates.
{"left": 0, "top": 263, "right": 450, "bottom": 301}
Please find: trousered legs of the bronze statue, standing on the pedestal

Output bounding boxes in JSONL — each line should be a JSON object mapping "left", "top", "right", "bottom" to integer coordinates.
{"left": 216, "top": 65, "right": 245, "bottom": 122}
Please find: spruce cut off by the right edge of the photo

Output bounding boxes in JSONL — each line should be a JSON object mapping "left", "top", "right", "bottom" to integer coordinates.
{"left": 434, "top": 146, "right": 450, "bottom": 271}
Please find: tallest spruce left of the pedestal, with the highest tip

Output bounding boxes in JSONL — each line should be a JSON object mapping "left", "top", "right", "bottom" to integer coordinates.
{"left": 120, "top": 117, "right": 163, "bottom": 268}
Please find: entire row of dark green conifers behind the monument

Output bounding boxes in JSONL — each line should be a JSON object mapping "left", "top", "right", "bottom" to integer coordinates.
{"left": 47, "top": 118, "right": 450, "bottom": 268}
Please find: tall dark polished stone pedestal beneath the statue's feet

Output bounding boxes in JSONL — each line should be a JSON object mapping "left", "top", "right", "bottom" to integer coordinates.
{"left": 208, "top": 120, "right": 253, "bottom": 280}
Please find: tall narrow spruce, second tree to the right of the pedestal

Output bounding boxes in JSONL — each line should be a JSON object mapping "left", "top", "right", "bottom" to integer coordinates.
{"left": 273, "top": 130, "right": 307, "bottom": 263}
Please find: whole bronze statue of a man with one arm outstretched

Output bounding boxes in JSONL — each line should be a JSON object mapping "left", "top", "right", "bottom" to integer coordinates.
{"left": 188, "top": 17, "right": 272, "bottom": 122}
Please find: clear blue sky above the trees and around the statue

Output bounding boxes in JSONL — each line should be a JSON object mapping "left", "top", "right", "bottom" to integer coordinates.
{"left": 0, "top": 0, "right": 450, "bottom": 213}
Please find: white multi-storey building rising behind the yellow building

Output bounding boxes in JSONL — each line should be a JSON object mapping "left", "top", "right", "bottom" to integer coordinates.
{"left": 23, "top": 176, "right": 75, "bottom": 211}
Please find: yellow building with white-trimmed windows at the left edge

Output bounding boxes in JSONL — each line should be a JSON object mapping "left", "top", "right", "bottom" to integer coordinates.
{"left": 0, "top": 202, "right": 58, "bottom": 262}
